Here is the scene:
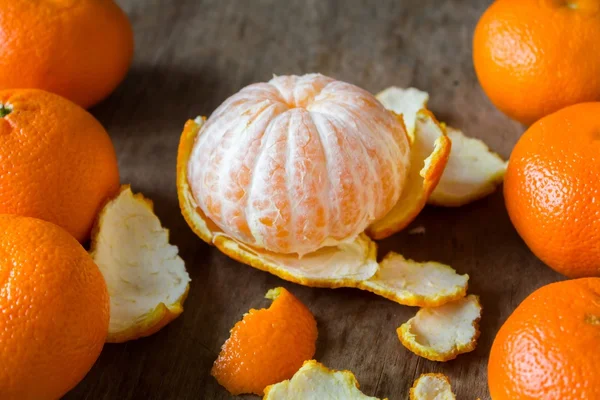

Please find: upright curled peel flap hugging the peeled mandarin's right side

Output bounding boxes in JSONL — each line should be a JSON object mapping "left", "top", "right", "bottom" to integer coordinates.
{"left": 367, "top": 110, "right": 452, "bottom": 239}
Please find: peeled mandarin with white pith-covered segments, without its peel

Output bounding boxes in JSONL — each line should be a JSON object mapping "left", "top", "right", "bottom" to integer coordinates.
{"left": 187, "top": 74, "right": 410, "bottom": 255}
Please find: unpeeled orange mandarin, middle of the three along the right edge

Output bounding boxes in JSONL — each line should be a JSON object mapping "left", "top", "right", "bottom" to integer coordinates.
{"left": 504, "top": 103, "right": 600, "bottom": 278}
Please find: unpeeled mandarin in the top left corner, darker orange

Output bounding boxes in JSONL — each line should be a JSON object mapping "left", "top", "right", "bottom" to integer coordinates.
{"left": 0, "top": 0, "right": 133, "bottom": 108}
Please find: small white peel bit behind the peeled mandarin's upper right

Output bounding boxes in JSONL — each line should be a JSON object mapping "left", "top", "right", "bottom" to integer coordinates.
{"left": 375, "top": 86, "right": 429, "bottom": 143}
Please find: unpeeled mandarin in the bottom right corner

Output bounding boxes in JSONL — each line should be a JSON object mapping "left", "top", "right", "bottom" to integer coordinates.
{"left": 488, "top": 278, "right": 600, "bottom": 400}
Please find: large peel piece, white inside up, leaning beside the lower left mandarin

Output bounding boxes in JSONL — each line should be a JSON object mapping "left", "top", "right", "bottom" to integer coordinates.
{"left": 90, "top": 185, "right": 190, "bottom": 343}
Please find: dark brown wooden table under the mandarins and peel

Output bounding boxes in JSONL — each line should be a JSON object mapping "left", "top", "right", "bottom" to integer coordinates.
{"left": 66, "top": 0, "right": 560, "bottom": 400}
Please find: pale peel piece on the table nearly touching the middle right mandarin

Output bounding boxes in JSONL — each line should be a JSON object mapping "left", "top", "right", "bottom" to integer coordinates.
{"left": 428, "top": 127, "right": 507, "bottom": 207}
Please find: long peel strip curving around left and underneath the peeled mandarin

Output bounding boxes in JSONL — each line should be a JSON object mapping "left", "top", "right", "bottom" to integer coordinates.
{"left": 177, "top": 117, "right": 468, "bottom": 307}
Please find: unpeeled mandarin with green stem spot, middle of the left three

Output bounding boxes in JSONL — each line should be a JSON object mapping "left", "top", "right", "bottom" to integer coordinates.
{"left": 0, "top": 89, "right": 119, "bottom": 242}
